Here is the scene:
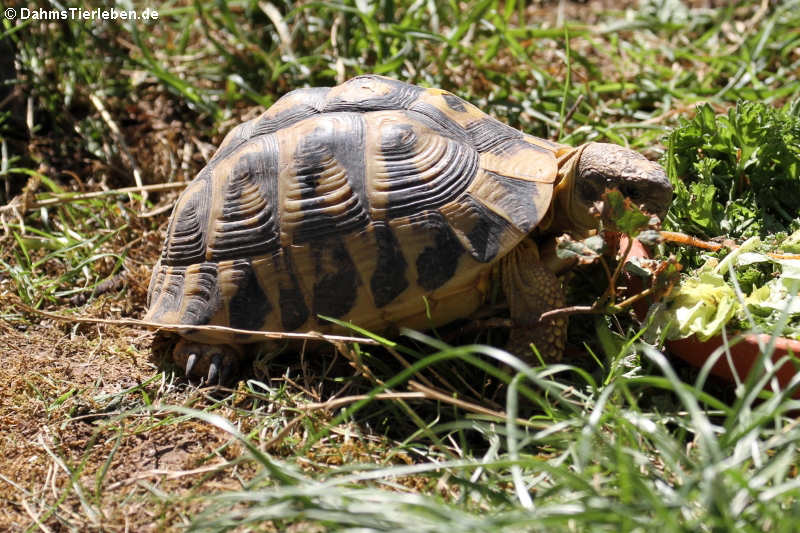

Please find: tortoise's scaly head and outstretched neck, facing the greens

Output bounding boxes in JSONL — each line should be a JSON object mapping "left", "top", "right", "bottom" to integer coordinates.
{"left": 557, "top": 143, "right": 672, "bottom": 229}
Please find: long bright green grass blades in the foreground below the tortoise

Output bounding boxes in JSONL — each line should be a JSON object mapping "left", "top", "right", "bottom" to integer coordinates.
{"left": 28, "top": 334, "right": 800, "bottom": 532}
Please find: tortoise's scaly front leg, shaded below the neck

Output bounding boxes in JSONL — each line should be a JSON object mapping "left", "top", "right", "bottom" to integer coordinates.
{"left": 501, "top": 239, "right": 567, "bottom": 363}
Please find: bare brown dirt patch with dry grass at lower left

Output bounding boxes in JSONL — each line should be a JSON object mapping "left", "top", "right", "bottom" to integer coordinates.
{"left": 0, "top": 296, "right": 236, "bottom": 531}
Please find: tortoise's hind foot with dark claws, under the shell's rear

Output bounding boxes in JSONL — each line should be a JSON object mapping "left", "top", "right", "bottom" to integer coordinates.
{"left": 172, "top": 338, "right": 243, "bottom": 385}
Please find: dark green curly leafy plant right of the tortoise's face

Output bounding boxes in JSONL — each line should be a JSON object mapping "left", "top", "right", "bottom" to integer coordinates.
{"left": 665, "top": 100, "right": 800, "bottom": 238}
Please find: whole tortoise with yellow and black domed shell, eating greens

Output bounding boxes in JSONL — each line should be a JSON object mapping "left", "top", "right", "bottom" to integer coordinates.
{"left": 145, "top": 75, "right": 672, "bottom": 382}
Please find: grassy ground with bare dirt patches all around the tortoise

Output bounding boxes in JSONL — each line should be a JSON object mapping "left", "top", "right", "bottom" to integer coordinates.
{"left": 0, "top": 0, "right": 800, "bottom": 532}
